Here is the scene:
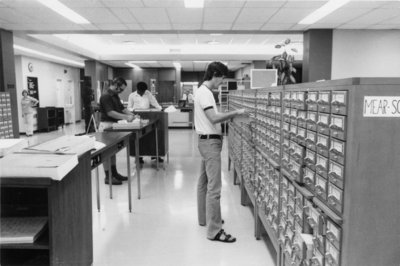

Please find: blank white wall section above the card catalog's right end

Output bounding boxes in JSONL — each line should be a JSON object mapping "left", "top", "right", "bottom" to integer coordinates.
{"left": 332, "top": 30, "right": 400, "bottom": 79}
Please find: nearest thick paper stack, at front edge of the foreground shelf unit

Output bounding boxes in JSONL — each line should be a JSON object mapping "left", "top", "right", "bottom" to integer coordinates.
{"left": 0, "top": 153, "right": 78, "bottom": 180}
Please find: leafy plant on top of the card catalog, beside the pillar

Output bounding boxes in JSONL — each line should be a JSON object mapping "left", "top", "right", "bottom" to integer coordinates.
{"left": 269, "top": 39, "right": 297, "bottom": 85}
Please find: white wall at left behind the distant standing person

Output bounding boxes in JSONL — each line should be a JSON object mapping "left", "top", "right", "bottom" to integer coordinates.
{"left": 15, "top": 56, "right": 82, "bottom": 132}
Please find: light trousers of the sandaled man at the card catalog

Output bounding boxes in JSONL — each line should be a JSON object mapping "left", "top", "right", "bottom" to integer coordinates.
{"left": 197, "top": 139, "right": 222, "bottom": 239}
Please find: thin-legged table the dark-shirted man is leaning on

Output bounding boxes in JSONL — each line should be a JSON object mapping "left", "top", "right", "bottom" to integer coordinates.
{"left": 105, "top": 119, "right": 158, "bottom": 199}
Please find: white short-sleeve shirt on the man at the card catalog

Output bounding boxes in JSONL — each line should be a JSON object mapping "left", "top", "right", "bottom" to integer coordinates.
{"left": 194, "top": 85, "right": 222, "bottom": 135}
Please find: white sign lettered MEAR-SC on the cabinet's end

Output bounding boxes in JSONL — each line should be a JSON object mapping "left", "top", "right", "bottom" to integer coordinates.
{"left": 363, "top": 96, "right": 400, "bottom": 117}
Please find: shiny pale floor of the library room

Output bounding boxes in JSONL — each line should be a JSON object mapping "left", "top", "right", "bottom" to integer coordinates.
{"left": 24, "top": 124, "right": 276, "bottom": 266}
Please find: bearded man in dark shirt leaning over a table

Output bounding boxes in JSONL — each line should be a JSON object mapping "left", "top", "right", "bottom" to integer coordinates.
{"left": 99, "top": 78, "right": 135, "bottom": 185}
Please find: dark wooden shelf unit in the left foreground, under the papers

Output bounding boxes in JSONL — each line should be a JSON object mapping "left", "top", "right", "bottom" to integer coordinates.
{"left": 0, "top": 152, "right": 93, "bottom": 266}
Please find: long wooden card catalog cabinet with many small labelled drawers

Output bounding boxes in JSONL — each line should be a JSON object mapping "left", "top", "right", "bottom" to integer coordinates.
{"left": 228, "top": 78, "right": 400, "bottom": 266}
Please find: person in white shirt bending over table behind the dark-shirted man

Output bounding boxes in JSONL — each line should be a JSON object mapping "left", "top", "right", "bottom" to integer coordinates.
{"left": 127, "top": 81, "right": 164, "bottom": 164}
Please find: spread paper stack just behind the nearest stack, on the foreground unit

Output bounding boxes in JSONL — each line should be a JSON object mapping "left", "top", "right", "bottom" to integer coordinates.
{"left": 26, "top": 136, "right": 96, "bottom": 155}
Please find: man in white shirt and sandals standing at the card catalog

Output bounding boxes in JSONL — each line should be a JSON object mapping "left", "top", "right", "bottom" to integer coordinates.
{"left": 194, "top": 62, "right": 245, "bottom": 243}
